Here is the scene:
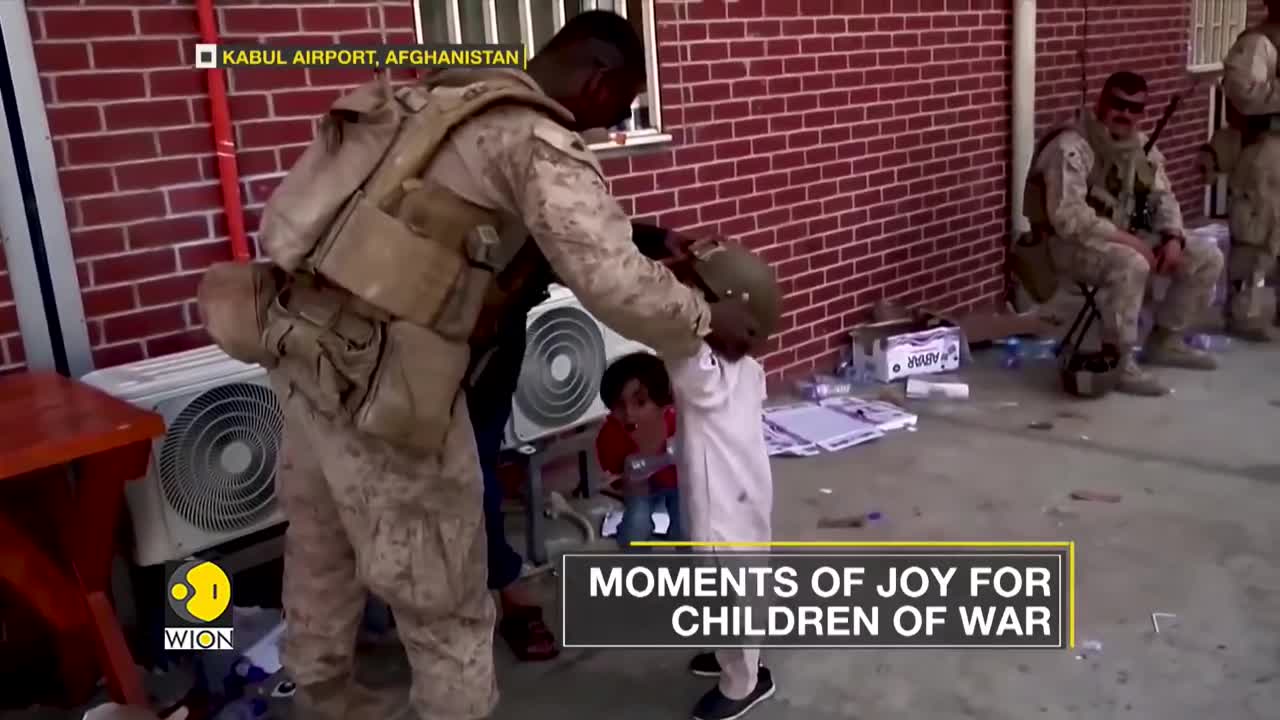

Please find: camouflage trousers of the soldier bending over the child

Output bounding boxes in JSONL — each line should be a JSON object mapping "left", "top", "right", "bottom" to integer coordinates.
{"left": 273, "top": 378, "right": 497, "bottom": 720}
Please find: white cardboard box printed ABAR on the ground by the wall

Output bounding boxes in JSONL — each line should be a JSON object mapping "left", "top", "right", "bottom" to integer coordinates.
{"left": 849, "top": 318, "right": 969, "bottom": 383}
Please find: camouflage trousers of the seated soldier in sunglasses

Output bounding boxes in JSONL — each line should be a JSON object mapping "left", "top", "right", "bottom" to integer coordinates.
{"left": 1050, "top": 230, "right": 1222, "bottom": 347}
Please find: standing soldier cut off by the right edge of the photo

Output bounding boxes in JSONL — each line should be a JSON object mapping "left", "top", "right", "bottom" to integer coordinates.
{"left": 1222, "top": 0, "right": 1280, "bottom": 342}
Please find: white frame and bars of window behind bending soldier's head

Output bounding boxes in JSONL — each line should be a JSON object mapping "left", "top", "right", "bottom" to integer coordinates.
{"left": 412, "top": 0, "right": 673, "bottom": 155}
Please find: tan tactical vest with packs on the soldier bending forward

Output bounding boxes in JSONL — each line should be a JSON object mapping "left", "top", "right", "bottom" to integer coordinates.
{"left": 200, "top": 70, "right": 572, "bottom": 452}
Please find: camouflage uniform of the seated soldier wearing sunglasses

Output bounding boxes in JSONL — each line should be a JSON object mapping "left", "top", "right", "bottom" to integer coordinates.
{"left": 1033, "top": 118, "right": 1222, "bottom": 395}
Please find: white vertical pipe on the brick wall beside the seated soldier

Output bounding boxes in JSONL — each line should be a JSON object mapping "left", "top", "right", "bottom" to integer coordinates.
{"left": 1009, "top": 0, "right": 1036, "bottom": 240}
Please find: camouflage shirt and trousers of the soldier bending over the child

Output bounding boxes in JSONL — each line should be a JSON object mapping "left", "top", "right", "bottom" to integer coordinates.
{"left": 273, "top": 73, "right": 710, "bottom": 720}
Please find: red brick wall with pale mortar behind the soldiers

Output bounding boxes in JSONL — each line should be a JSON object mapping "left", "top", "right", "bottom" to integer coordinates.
{"left": 0, "top": 0, "right": 1228, "bottom": 374}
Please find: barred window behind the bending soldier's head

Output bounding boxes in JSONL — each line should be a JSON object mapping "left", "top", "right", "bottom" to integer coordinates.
{"left": 413, "top": 0, "right": 671, "bottom": 151}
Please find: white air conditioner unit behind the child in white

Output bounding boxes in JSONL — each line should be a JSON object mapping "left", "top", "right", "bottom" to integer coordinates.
{"left": 504, "top": 284, "right": 653, "bottom": 447}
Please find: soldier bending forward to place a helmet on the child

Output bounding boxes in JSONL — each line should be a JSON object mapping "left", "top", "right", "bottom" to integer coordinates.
{"left": 201, "top": 12, "right": 755, "bottom": 720}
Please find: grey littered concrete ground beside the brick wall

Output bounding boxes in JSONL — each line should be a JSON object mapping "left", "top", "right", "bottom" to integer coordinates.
{"left": 12, "top": 345, "right": 1280, "bottom": 720}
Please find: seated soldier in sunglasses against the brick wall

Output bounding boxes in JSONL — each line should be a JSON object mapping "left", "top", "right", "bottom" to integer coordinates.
{"left": 1027, "top": 72, "right": 1222, "bottom": 396}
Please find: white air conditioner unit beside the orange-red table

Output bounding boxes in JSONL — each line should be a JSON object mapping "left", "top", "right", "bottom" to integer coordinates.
{"left": 81, "top": 346, "right": 284, "bottom": 566}
